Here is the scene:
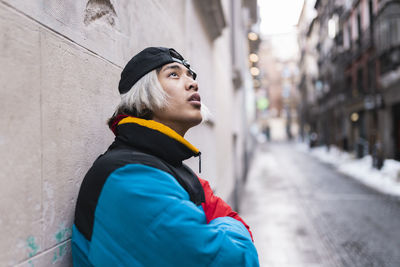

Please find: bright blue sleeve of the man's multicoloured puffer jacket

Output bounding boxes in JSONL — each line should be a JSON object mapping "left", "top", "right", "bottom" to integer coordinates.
{"left": 88, "top": 164, "right": 259, "bottom": 267}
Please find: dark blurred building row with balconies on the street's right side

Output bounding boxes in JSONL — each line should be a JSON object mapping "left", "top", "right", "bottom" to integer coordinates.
{"left": 299, "top": 0, "right": 400, "bottom": 163}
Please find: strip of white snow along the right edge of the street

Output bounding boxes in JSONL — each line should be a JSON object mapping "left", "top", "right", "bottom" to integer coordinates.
{"left": 296, "top": 143, "right": 400, "bottom": 196}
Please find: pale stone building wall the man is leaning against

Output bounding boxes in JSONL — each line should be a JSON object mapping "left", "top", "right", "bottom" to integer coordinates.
{"left": 0, "top": 0, "right": 258, "bottom": 266}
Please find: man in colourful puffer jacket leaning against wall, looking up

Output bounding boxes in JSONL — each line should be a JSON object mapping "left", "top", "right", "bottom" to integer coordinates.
{"left": 72, "top": 47, "right": 258, "bottom": 266}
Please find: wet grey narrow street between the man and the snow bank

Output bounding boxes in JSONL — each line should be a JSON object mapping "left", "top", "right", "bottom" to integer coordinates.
{"left": 240, "top": 142, "right": 400, "bottom": 267}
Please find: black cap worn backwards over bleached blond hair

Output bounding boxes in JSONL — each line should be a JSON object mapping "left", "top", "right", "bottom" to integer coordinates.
{"left": 118, "top": 47, "right": 197, "bottom": 94}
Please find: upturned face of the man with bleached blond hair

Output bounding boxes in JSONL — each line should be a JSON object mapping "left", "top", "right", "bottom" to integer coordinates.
{"left": 153, "top": 62, "right": 202, "bottom": 136}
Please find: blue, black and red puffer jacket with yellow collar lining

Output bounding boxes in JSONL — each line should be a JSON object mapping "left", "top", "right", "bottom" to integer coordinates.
{"left": 72, "top": 117, "right": 259, "bottom": 267}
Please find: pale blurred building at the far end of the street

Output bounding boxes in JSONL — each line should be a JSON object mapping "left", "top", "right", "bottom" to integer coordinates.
{"left": 257, "top": 38, "right": 300, "bottom": 140}
